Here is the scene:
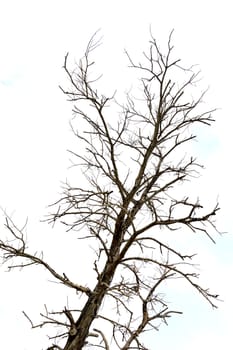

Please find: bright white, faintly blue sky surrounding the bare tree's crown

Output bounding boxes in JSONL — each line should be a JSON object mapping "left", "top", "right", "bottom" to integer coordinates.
{"left": 0, "top": 0, "right": 233, "bottom": 350}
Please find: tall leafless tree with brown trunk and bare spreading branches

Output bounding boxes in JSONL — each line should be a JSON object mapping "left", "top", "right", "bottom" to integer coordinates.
{"left": 0, "top": 30, "right": 219, "bottom": 350}
